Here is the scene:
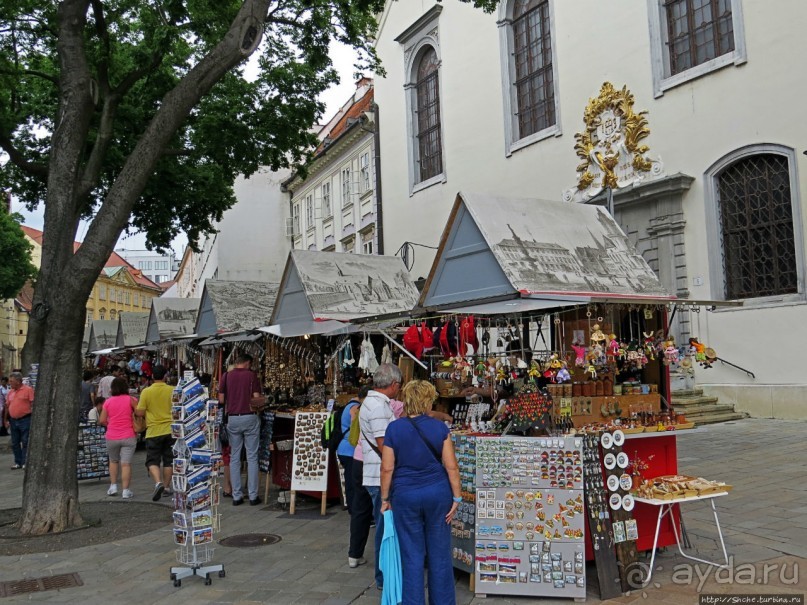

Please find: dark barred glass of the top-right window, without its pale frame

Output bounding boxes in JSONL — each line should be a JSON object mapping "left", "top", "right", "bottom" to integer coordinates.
{"left": 664, "top": 0, "right": 734, "bottom": 75}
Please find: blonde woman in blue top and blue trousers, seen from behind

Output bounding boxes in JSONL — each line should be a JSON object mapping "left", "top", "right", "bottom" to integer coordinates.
{"left": 381, "top": 380, "right": 462, "bottom": 605}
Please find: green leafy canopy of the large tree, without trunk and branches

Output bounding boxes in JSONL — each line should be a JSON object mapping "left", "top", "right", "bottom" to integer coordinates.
{"left": 0, "top": 0, "right": 383, "bottom": 247}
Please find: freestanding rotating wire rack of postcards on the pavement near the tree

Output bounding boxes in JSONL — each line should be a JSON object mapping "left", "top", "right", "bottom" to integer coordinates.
{"left": 171, "top": 379, "right": 225, "bottom": 586}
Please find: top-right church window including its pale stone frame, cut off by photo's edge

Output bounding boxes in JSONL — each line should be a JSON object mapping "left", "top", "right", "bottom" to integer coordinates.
{"left": 647, "top": 0, "right": 746, "bottom": 96}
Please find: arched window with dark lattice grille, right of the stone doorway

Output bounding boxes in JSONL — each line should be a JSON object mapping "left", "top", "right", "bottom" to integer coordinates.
{"left": 717, "top": 154, "right": 798, "bottom": 298}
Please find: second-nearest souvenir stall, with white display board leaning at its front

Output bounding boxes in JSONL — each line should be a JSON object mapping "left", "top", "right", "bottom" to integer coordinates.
{"left": 262, "top": 250, "right": 417, "bottom": 510}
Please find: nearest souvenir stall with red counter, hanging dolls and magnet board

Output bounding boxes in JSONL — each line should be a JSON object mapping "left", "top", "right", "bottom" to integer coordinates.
{"left": 410, "top": 193, "right": 732, "bottom": 598}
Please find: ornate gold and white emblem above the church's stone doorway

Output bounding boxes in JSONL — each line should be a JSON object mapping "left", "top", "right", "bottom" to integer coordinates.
{"left": 564, "top": 82, "right": 663, "bottom": 201}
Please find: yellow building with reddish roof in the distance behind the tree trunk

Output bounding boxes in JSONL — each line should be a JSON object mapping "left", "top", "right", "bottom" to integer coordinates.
{"left": 0, "top": 225, "right": 162, "bottom": 376}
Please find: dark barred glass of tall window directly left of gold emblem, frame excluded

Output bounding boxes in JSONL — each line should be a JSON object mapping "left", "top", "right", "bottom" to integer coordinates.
{"left": 513, "top": 0, "right": 555, "bottom": 139}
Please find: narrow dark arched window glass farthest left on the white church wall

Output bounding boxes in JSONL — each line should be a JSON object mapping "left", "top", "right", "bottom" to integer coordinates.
{"left": 413, "top": 46, "right": 443, "bottom": 183}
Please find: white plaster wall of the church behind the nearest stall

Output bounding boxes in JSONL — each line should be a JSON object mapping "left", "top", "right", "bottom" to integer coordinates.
{"left": 375, "top": 0, "right": 807, "bottom": 407}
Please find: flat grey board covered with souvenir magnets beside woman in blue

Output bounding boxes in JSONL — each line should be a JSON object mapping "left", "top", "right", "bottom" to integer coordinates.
{"left": 474, "top": 437, "right": 586, "bottom": 598}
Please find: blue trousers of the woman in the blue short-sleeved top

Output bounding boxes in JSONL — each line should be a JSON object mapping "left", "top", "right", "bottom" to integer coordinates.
{"left": 391, "top": 480, "right": 456, "bottom": 605}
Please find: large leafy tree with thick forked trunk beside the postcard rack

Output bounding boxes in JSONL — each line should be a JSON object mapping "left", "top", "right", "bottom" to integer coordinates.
{"left": 0, "top": 0, "right": 383, "bottom": 534}
